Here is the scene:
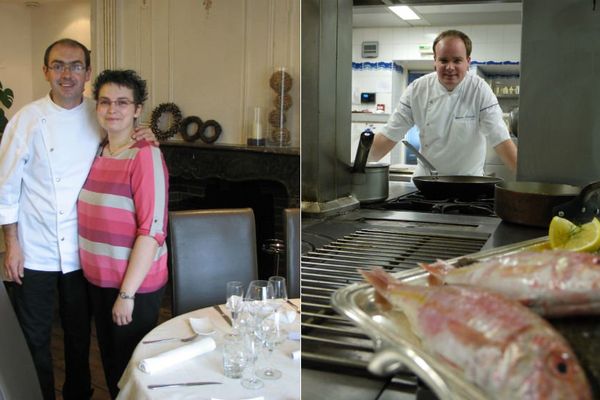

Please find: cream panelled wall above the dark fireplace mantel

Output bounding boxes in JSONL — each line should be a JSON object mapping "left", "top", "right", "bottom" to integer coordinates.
{"left": 93, "top": 0, "right": 300, "bottom": 147}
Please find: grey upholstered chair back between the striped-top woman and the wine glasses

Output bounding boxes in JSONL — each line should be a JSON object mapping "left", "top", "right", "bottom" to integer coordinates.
{"left": 169, "top": 208, "right": 258, "bottom": 316}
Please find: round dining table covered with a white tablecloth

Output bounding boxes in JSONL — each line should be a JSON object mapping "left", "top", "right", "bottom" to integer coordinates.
{"left": 118, "top": 299, "right": 300, "bottom": 400}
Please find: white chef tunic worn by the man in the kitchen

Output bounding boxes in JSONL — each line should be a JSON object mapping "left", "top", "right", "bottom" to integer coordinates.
{"left": 382, "top": 72, "right": 510, "bottom": 176}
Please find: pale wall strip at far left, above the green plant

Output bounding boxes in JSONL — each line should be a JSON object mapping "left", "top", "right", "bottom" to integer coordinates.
{"left": 0, "top": 3, "right": 33, "bottom": 119}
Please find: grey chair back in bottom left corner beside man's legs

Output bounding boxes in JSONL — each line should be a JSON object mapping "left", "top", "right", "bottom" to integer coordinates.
{"left": 0, "top": 283, "right": 42, "bottom": 400}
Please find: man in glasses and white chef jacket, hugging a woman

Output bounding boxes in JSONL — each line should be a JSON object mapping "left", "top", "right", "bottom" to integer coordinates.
{"left": 0, "top": 39, "right": 152, "bottom": 399}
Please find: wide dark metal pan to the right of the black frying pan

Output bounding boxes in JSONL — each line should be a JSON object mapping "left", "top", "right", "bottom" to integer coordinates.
{"left": 494, "top": 181, "right": 581, "bottom": 228}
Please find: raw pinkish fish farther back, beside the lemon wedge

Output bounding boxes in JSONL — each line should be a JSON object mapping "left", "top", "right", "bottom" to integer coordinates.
{"left": 420, "top": 250, "right": 600, "bottom": 317}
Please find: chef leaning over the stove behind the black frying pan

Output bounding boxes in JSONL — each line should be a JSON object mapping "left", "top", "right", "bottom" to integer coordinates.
{"left": 370, "top": 30, "right": 517, "bottom": 176}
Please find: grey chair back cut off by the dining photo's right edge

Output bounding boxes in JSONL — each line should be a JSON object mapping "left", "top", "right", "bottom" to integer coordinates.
{"left": 283, "top": 208, "right": 300, "bottom": 298}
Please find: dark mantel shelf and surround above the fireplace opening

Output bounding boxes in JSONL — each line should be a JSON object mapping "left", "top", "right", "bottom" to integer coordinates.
{"left": 160, "top": 140, "right": 300, "bottom": 207}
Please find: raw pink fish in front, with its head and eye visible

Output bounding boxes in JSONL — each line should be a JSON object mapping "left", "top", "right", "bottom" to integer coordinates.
{"left": 361, "top": 269, "right": 592, "bottom": 400}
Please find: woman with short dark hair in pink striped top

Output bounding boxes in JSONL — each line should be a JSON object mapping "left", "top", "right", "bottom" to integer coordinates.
{"left": 77, "top": 70, "right": 168, "bottom": 398}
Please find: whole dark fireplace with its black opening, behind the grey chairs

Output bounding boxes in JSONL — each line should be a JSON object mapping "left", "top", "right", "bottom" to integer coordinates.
{"left": 161, "top": 142, "right": 300, "bottom": 278}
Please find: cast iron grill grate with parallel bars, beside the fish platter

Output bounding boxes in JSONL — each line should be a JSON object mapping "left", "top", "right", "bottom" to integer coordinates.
{"left": 301, "top": 228, "right": 485, "bottom": 393}
